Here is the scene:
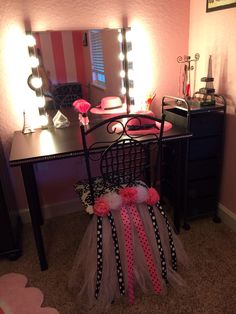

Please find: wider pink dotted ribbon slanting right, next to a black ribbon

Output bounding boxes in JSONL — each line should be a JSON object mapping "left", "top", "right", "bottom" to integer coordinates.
{"left": 129, "top": 205, "right": 161, "bottom": 294}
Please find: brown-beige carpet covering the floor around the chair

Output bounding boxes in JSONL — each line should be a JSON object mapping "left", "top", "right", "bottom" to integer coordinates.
{"left": 0, "top": 213, "right": 236, "bottom": 314}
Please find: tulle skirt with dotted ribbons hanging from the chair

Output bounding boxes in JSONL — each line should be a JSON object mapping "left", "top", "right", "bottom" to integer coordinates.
{"left": 69, "top": 185, "right": 187, "bottom": 313}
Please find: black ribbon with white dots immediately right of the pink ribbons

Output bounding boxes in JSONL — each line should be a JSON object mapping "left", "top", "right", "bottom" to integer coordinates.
{"left": 148, "top": 206, "right": 167, "bottom": 281}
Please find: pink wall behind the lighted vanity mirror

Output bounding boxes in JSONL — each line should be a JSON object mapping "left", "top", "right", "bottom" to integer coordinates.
{"left": 0, "top": 0, "right": 190, "bottom": 213}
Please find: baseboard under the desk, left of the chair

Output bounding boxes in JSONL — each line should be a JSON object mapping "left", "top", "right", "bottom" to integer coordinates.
{"left": 19, "top": 199, "right": 83, "bottom": 224}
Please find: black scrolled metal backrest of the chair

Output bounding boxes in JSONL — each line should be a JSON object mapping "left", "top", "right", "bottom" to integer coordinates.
{"left": 80, "top": 114, "right": 165, "bottom": 204}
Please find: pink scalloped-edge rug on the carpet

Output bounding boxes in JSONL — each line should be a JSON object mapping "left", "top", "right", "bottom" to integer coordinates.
{"left": 0, "top": 273, "right": 59, "bottom": 314}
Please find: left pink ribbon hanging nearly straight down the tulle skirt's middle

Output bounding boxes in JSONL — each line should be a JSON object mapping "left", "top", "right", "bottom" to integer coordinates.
{"left": 121, "top": 206, "right": 134, "bottom": 304}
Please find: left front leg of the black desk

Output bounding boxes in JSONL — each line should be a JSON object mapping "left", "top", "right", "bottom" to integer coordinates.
{"left": 21, "top": 164, "right": 48, "bottom": 270}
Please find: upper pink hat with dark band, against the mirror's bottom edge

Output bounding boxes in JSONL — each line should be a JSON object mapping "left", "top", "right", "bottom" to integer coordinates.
{"left": 90, "top": 96, "right": 126, "bottom": 114}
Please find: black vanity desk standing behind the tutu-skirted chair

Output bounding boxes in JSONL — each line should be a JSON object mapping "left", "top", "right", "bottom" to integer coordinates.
{"left": 10, "top": 113, "right": 191, "bottom": 270}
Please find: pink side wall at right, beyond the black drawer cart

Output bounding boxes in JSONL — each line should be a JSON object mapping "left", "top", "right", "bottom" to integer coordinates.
{"left": 189, "top": 0, "right": 236, "bottom": 213}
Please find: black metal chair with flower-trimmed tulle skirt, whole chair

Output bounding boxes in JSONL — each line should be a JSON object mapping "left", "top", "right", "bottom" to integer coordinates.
{"left": 69, "top": 114, "right": 186, "bottom": 313}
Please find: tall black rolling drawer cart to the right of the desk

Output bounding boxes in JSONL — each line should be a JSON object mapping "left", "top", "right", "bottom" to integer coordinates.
{"left": 162, "top": 95, "right": 226, "bottom": 229}
